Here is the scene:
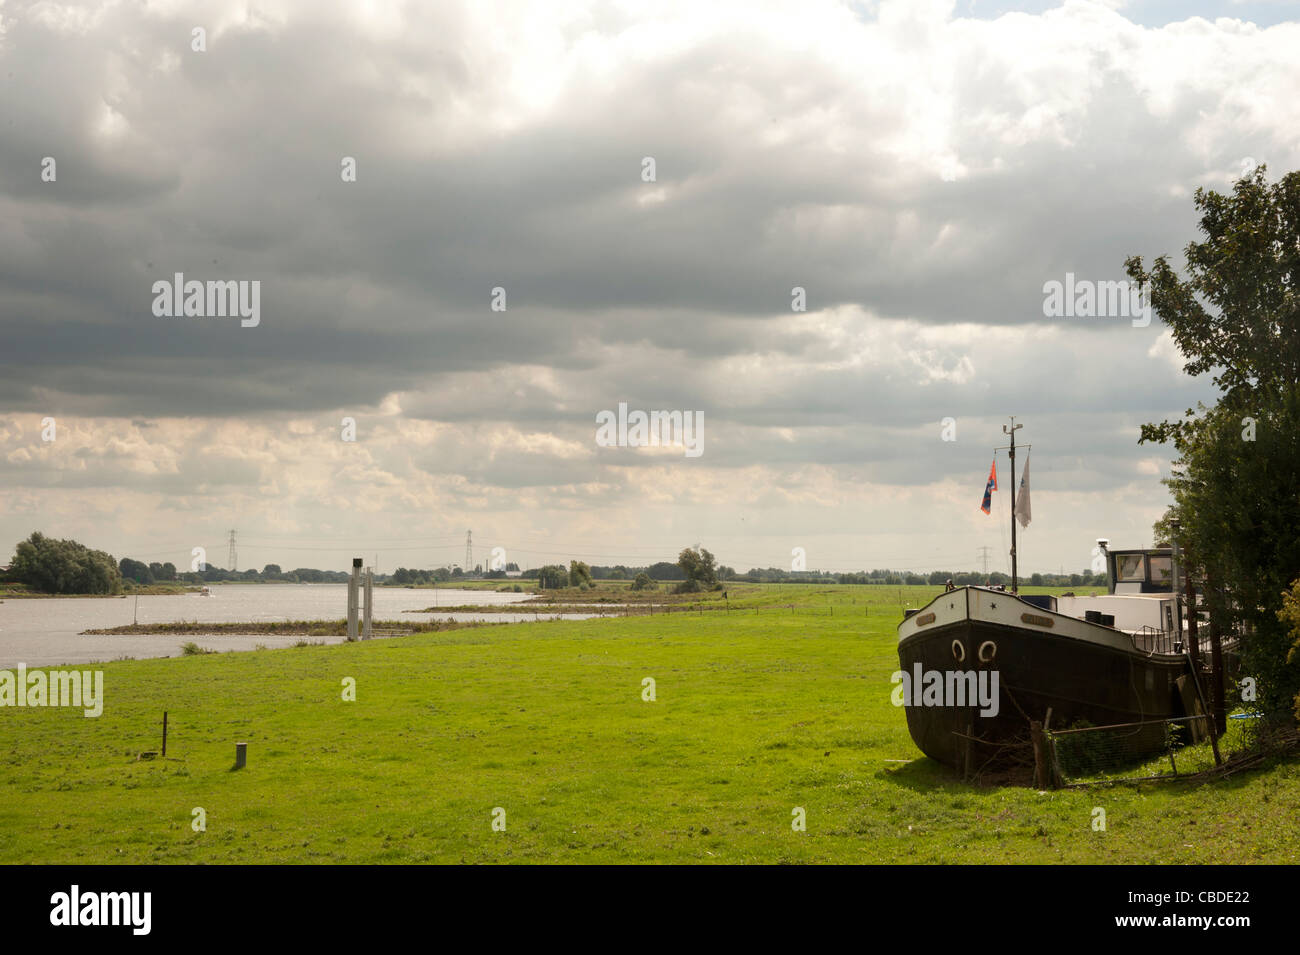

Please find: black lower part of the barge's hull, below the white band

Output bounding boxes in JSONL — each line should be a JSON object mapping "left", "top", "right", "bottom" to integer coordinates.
{"left": 898, "top": 615, "right": 1187, "bottom": 772}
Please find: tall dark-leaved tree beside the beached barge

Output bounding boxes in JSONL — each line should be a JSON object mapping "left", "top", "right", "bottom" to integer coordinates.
{"left": 1126, "top": 166, "right": 1300, "bottom": 716}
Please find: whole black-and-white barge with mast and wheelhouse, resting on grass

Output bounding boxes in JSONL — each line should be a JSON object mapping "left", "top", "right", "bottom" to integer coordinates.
{"left": 896, "top": 422, "right": 1216, "bottom": 772}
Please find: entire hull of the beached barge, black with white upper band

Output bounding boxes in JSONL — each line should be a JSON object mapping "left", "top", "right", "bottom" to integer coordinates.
{"left": 898, "top": 589, "right": 1187, "bottom": 772}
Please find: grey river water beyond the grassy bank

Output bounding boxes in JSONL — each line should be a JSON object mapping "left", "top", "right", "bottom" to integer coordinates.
{"left": 0, "top": 583, "right": 590, "bottom": 669}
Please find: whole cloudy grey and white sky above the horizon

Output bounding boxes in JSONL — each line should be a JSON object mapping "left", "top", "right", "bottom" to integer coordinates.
{"left": 0, "top": 0, "right": 1300, "bottom": 573}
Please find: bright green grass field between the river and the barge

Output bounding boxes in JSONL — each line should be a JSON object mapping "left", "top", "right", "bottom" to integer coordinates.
{"left": 0, "top": 585, "right": 1300, "bottom": 863}
